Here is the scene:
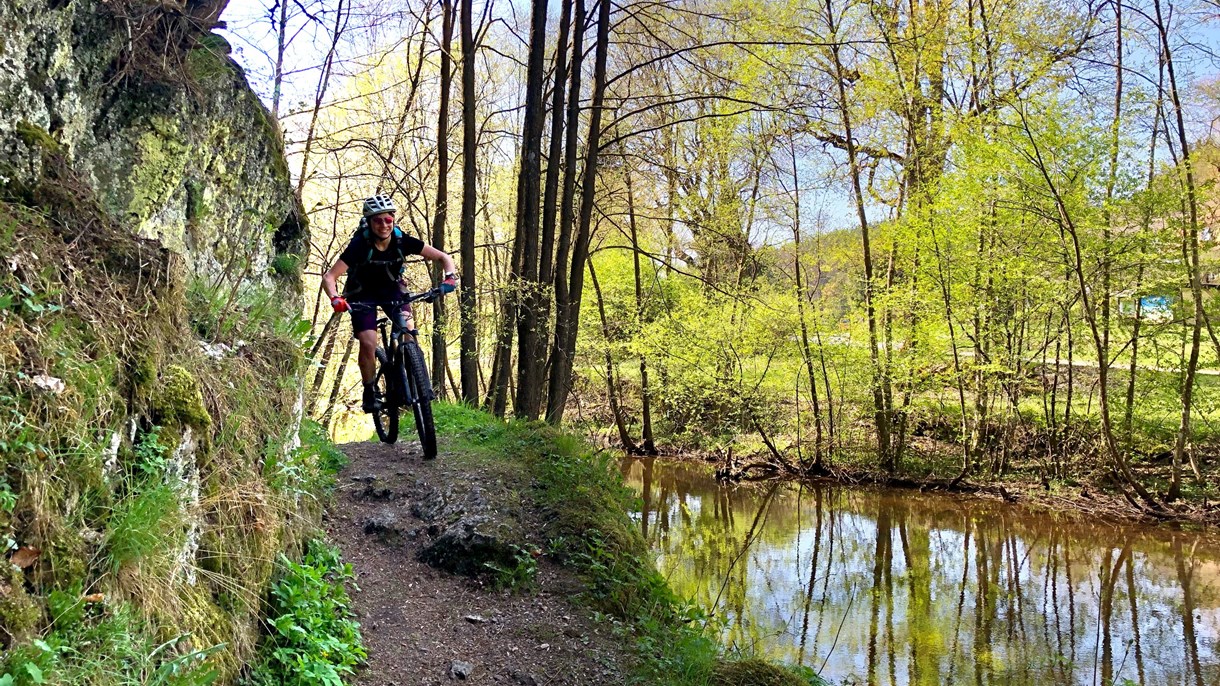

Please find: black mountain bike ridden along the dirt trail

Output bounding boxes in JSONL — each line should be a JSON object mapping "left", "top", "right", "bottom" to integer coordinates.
{"left": 350, "top": 288, "right": 443, "bottom": 460}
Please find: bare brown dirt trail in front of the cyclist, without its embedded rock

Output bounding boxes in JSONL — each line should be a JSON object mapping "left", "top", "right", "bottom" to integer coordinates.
{"left": 327, "top": 443, "right": 628, "bottom": 686}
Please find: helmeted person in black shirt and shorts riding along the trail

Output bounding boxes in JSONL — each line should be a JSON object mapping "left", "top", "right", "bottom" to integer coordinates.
{"left": 322, "top": 195, "right": 458, "bottom": 413}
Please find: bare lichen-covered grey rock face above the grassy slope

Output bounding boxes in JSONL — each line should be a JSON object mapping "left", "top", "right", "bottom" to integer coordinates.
{"left": 0, "top": 0, "right": 306, "bottom": 289}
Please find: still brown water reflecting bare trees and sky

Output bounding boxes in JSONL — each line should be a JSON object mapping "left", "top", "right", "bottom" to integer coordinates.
{"left": 622, "top": 460, "right": 1220, "bottom": 686}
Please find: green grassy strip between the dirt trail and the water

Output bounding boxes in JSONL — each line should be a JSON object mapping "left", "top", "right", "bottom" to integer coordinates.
{"left": 433, "top": 403, "right": 820, "bottom": 686}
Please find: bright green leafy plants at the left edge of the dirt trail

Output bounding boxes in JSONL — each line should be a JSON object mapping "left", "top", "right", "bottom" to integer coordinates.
{"left": 250, "top": 540, "right": 365, "bottom": 686}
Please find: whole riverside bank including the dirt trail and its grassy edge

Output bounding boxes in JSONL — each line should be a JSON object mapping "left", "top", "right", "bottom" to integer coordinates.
{"left": 327, "top": 403, "right": 820, "bottom": 686}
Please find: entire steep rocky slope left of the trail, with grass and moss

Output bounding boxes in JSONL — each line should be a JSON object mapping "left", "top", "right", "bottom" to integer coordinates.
{"left": 0, "top": 0, "right": 312, "bottom": 684}
